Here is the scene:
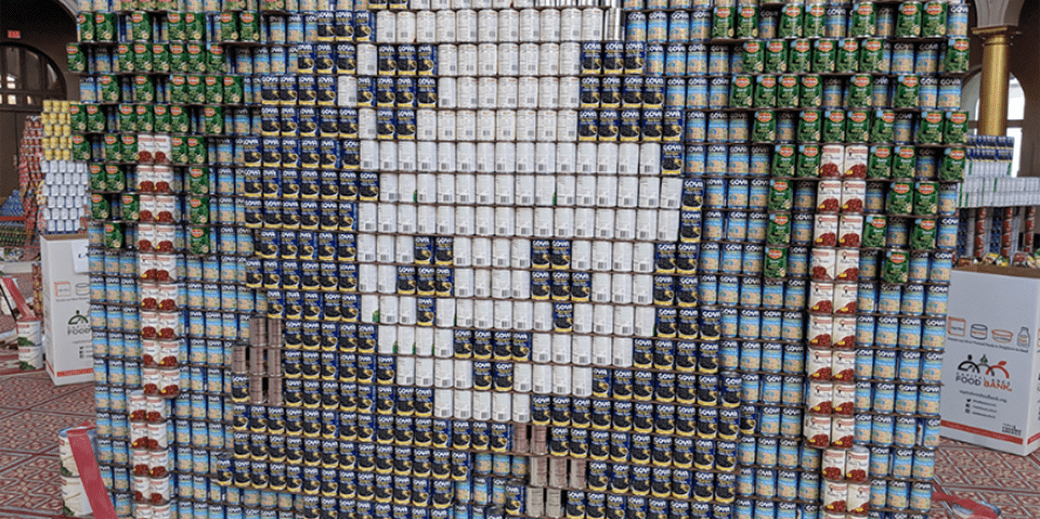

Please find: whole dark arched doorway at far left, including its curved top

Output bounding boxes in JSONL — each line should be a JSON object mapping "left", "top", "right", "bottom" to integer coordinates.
{"left": 0, "top": 43, "right": 68, "bottom": 197}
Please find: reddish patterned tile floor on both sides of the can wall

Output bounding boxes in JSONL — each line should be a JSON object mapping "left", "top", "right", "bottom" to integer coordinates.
{"left": 0, "top": 371, "right": 1040, "bottom": 519}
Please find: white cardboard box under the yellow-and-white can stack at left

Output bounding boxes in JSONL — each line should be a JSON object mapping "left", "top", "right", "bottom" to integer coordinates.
{"left": 40, "top": 234, "right": 94, "bottom": 386}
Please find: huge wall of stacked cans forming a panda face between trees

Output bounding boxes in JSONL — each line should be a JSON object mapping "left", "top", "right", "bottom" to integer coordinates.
{"left": 75, "top": 0, "right": 967, "bottom": 519}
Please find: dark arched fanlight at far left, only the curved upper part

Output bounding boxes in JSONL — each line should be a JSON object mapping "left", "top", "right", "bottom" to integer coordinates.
{"left": 0, "top": 44, "right": 66, "bottom": 109}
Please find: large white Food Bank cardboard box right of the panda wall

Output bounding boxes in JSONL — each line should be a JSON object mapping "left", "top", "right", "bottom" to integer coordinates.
{"left": 940, "top": 265, "right": 1040, "bottom": 456}
